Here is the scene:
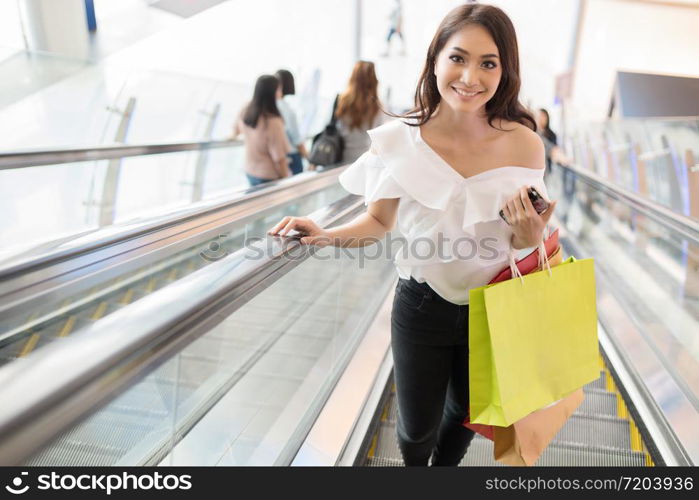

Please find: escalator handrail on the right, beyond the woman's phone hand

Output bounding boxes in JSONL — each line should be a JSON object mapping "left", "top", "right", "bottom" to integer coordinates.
{"left": 557, "top": 164, "right": 699, "bottom": 244}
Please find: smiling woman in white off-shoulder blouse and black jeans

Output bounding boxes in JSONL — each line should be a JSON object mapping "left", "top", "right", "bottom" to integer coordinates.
{"left": 270, "top": 4, "right": 556, "bottom": 466}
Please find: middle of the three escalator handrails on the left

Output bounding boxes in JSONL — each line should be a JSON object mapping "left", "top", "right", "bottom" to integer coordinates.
{"left": 0, "top": 165, "right": 344, "bottom": 283}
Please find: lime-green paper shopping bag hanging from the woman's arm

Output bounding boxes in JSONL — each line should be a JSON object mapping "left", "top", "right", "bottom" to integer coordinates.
{"left": 469, "top": 257, "right": 599, "bottom": 427}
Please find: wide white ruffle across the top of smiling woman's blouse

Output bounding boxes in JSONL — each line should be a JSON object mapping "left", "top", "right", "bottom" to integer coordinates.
{"left": 339, "top": 120, "right": 548, "bottom": 234}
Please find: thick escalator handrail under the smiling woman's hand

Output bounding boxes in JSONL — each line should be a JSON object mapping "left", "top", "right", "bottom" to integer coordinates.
{"left": 0, "top": 195, "right": 364, "bottom": 465}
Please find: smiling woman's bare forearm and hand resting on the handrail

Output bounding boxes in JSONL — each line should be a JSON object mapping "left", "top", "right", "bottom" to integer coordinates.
{"left": 269, "top": 198, "right": 400, "bottom": 248}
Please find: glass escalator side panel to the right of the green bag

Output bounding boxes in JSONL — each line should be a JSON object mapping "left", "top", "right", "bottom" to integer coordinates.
{"left": 547, "top": 167, "right": 699, "bottom": 460}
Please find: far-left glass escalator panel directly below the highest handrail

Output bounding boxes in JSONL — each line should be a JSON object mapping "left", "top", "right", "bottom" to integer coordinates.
{"left": 0, "top": 147, "right": 248, "bottom": 262}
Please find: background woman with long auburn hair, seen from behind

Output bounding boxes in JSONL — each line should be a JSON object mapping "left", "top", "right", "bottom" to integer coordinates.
{"left": 335, "top": 61, "right": 386, "bottom": 164}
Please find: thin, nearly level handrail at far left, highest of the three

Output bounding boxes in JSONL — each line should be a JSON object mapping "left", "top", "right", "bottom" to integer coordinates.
{"left": 0, "top": 140, "right": 244, "bottom": 170}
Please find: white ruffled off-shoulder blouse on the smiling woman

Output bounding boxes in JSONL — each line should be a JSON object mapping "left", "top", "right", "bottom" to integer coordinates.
{"left": 340, "top": 120, "right": 548, "bottom": 304}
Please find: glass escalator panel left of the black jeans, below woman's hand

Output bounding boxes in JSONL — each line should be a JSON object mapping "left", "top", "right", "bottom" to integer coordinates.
{"left": 27, "top": 230, "right": 395, "bottom": 465}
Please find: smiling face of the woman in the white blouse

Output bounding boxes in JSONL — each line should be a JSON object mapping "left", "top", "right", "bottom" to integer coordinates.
{"left": 434, "top": 24, "right": 502, "bottom": 112}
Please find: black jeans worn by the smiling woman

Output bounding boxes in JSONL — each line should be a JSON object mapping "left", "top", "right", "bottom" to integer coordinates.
{"left": 391, "top": 279, "right": 474, "bottom": 466}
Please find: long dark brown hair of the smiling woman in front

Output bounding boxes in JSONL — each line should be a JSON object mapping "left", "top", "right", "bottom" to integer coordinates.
{"left": 401, "top": 3, "right": 536, "bottom": 130}
